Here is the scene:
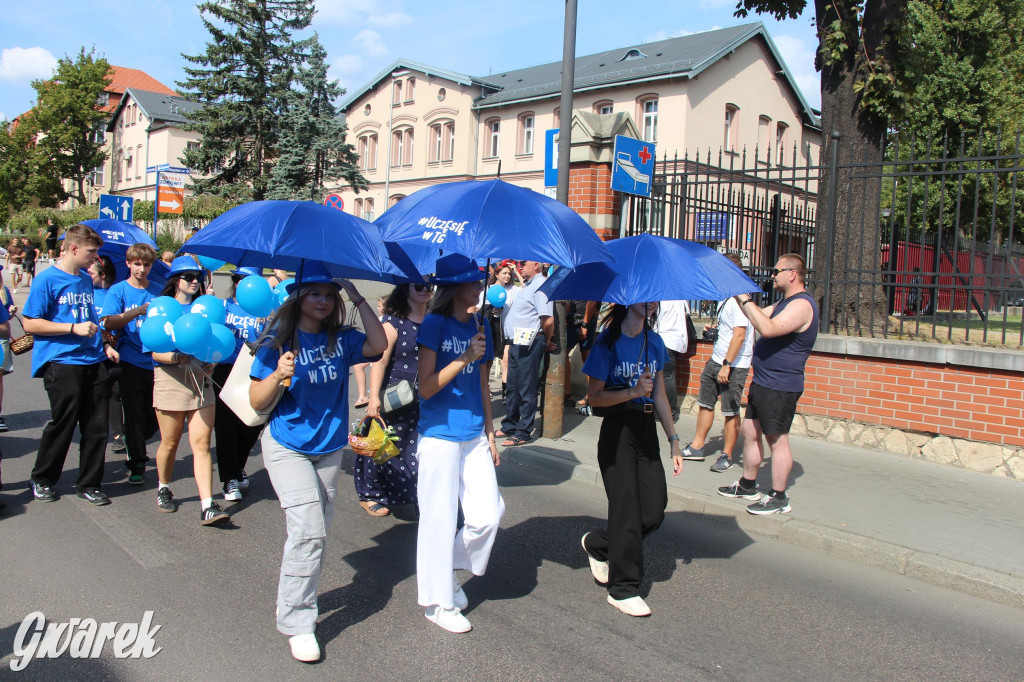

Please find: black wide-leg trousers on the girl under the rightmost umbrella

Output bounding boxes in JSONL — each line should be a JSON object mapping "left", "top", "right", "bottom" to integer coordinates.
{"left": 587, "top": 412, "right": 669, "bottom": 599}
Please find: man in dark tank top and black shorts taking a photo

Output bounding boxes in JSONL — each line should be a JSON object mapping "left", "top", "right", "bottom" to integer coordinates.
{"left": 718, "top": 253, "right": 818, "bottom": 514}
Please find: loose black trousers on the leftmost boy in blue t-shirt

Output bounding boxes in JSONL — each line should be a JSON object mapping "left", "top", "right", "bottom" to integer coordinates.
{"left": 32, "top": 363, "right": 106, "bottom": 491}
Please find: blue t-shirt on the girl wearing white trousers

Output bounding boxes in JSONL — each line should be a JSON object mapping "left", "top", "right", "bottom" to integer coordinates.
{"left": 416, "top": 314, "right": 495, "bottom": 442}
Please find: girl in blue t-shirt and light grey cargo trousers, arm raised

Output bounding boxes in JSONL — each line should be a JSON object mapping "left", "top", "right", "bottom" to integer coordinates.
{"left": 249, "top": 263, "right": 387, "bottom": 662}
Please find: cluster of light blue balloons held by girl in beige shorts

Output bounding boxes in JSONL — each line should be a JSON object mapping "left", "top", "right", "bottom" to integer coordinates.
{"left": 139, "top": 294, "right": 235, "bottom": 364}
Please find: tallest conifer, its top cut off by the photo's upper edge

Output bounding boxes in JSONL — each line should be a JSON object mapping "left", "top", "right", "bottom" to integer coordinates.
{"left": 178, "top": 0, "right": 314, "bottom": 201}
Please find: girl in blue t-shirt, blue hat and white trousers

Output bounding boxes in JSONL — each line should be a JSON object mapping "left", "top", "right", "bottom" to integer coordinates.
{"left": 416, "top": 260, "right": 505, "bottom": 633}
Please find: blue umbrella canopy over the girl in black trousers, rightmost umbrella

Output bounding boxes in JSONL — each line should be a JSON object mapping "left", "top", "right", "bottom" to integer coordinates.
{"left": 541, "top": 235, "right": 759, "bottom": 305}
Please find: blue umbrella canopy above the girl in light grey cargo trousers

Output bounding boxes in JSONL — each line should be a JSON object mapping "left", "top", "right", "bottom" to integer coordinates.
{"left": 179, "top": 201, "right": 422, "bottom": 283}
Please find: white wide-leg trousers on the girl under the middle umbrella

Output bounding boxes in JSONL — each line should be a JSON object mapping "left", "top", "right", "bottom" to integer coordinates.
{"left": 416, "top": 431, "right": 505, "bottom": 608}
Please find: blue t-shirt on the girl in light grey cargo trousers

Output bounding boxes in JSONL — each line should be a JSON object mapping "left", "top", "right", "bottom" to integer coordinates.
{"left": 249, "top": 329, "right": 380, "bottom": 455}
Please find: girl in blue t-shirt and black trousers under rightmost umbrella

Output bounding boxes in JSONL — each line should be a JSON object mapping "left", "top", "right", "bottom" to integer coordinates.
{"left": 582, "top": 303, "right": 683, "bottom": 615}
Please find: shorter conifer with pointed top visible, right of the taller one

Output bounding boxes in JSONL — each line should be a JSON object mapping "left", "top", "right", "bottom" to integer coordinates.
{"left": 267, "top": 35, "right": 367, "bottom": 202}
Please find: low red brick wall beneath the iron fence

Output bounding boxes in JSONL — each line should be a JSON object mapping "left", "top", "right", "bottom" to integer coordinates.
{"left": 676, "top": 341, "right": 1024, "bottom": 447}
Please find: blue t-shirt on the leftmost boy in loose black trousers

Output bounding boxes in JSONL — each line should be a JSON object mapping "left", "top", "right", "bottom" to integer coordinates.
{"left": 24, "top": 267, "right": 105, "bottom": 377}
